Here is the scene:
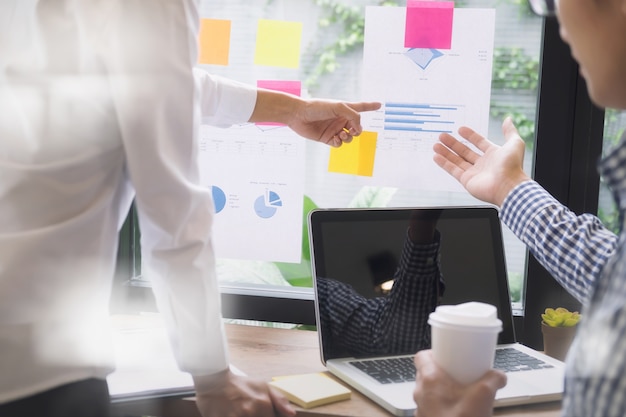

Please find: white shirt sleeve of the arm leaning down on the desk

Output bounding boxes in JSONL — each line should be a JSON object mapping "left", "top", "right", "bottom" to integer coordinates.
{"left": 106, "top": 0, "right": 228, "bottom": 375}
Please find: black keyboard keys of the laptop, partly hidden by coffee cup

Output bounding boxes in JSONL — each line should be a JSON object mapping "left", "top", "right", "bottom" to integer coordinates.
{"left": 350, "top": 348, "right": 552, "bottom": 384}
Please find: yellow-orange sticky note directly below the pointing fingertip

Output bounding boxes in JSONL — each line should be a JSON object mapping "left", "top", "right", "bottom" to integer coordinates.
{"left": 328, "top": 131, "right": 378, "bottom": 177}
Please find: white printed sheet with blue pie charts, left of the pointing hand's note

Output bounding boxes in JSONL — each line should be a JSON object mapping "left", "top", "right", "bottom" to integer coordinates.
{"left": 199, "top": 123, "right": 305, "bottom": 263}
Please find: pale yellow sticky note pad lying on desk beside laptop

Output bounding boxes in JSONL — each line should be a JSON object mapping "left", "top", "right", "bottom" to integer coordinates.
{"left": 270, "top": 373, "right": 351, "bottom": 408}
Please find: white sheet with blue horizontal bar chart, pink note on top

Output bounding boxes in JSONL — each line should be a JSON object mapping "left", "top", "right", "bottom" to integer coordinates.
{"left": 362, "top": 7, "right": 495, "bottom": 191}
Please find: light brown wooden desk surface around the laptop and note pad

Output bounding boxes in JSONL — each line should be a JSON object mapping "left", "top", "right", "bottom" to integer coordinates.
{"left": 114, "top": 325, "right": 560, "bottom": 417}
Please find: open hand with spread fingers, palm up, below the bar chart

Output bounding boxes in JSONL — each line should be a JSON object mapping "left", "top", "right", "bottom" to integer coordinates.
{"left": 433, "top": 117, "right": 530, "bottom": 206}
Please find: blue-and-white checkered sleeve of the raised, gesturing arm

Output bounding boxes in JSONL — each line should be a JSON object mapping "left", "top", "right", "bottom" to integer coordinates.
{"left": 500, "top": 181, "right": 617, "bottom": 303}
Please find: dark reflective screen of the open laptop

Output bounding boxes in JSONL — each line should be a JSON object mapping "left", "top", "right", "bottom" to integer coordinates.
{"left": 309, "top": 206, "right": 515, "bottom": 361}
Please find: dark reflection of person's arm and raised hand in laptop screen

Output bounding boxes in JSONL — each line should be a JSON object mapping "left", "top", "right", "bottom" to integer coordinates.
{"left": 316, "top": 210, "right": 444, "bottom": 357}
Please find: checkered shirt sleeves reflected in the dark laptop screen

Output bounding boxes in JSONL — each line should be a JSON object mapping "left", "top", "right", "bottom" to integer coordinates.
{"left": 317, "top": 233, "right": 443, "bottom": 357}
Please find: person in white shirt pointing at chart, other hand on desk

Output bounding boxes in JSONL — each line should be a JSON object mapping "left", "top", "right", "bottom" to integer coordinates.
{"left": 0, "top": 0, "right": 379, "bottom": 417}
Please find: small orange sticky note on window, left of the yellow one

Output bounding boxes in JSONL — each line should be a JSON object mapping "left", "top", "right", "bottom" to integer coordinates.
{"left": 198, "top": 19, "right": 231, "bottom": 65}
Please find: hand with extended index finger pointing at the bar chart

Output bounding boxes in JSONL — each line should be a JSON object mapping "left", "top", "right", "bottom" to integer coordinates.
{"left": 289, "top": 100, "right": 381, "bottom": 147}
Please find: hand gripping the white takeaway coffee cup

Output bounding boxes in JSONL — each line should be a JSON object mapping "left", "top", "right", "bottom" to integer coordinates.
{"left": 413, "top": 350, "right": 506, "bottom": 417}
